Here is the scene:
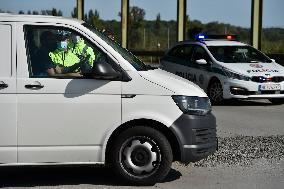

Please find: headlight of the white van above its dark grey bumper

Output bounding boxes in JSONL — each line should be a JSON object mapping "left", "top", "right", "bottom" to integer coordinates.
{"left": 172, "top": 95, "right": 211, "bottom": 115}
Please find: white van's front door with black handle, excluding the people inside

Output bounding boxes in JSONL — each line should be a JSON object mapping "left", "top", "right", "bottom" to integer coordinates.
{"left": 17, "top": 23, "right": 121, "bottom": 163}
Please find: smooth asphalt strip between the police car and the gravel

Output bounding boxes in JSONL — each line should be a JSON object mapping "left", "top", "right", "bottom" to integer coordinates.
{"left": 213, "top": 100, "right": 284, "bottom": 137}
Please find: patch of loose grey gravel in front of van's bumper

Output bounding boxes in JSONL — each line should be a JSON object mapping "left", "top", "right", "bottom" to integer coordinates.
{"left": 194, "top": 135, "right": 284, "bottom": 167}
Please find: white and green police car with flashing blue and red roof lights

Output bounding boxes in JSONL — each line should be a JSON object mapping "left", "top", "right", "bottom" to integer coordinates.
{"left": 161, "top": 35, "right": 284, "bottom": 104}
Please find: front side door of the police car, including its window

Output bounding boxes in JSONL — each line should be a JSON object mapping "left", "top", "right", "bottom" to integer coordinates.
{"left": 190, "top": 45, "right": 211, "bottom": 92}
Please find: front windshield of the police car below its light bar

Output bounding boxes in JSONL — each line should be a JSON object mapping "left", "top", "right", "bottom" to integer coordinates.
{"left": 208, "top": 46, "right": 272, "bottom": 63}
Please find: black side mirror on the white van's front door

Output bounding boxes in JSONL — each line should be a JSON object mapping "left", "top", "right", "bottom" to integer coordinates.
{"left": 88, "top": 61, "right": 122, "bottom": 80}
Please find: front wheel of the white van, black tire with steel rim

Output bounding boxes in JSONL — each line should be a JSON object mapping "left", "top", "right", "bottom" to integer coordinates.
{"left": 110, "top": 126, "right": 173, "bottom": 185}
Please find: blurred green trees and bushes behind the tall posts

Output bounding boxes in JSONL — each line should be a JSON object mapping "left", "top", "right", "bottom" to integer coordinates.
{"left": 0, "top": 6, "right": 284, "bottom": 53}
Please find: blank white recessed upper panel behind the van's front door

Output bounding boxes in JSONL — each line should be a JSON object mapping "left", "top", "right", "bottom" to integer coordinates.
{"left": 0, "top": 24, "right": 12, "bottom": 77}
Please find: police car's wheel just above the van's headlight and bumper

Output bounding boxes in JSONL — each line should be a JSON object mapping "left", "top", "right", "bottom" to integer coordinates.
{"left": 207, "top": 80, "right": 224, "bottom": 104}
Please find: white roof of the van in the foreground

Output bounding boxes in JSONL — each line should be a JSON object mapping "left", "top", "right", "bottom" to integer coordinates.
{"left": 0, "top": 13, "right": 84, "bottom": 24}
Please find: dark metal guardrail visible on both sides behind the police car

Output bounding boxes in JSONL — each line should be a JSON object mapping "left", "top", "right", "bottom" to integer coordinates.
{"left": 131, "top": 50, "right": 284, "bottom": 66}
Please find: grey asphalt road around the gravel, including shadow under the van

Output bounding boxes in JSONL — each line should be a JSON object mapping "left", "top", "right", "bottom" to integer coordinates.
{"left": 0, "top": 100, "right": 284, "bottom": 189}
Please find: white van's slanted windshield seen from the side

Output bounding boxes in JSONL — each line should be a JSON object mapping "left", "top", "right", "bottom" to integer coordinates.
{"left": 82, "top": 23, "right": 149, "bottom": 71}
